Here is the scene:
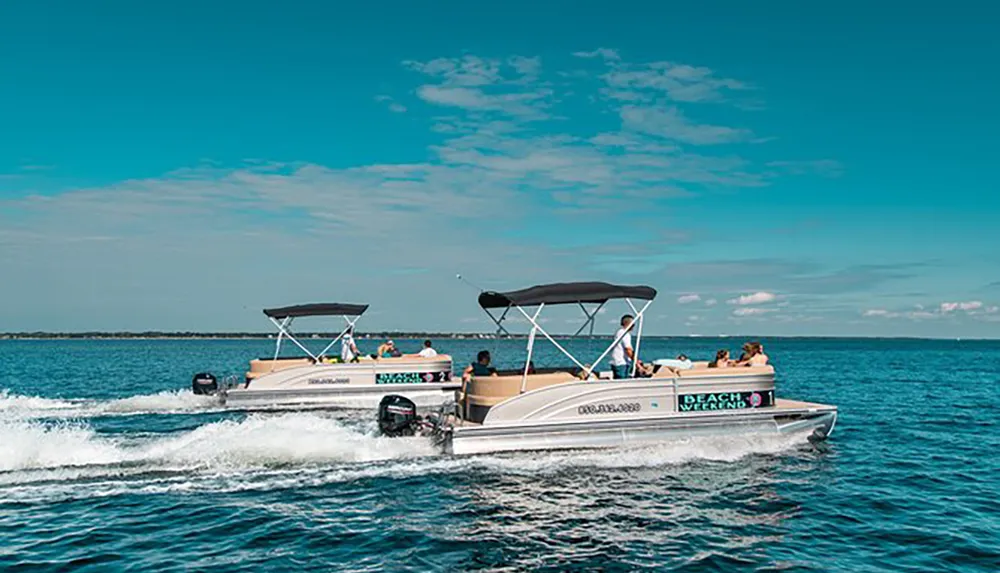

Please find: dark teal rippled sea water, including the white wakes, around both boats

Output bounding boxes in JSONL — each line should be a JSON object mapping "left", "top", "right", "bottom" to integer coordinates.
{"left": 0, "top": 338, "right": 1000, "bottom": 573}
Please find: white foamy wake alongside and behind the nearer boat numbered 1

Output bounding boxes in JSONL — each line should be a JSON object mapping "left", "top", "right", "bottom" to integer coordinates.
{"left": 0, "top": 404, "right": 807, "bottom": 504}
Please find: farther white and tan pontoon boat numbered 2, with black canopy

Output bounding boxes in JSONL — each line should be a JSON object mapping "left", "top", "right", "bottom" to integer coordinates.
{"left": 192, "top": 303, "right": 459, "bottom": 408}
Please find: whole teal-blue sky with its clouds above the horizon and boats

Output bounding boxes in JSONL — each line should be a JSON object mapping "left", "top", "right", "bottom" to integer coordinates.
{"left": 0, "top": 1, "right": 1000, "bottom": 337}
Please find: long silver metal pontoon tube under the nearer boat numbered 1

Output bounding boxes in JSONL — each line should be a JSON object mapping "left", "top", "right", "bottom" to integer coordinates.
{"left": 440, "top": 402, "right": 837, "bottom": 455}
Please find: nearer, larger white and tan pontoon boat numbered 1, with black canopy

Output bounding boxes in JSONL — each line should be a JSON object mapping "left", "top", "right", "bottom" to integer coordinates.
{"left": 379, "top": 283, "right": 837, "bottom": 454}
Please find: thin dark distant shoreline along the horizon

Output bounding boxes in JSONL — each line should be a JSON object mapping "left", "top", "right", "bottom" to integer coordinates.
{"left": 0, "top": 331, "right": 1000, "bottom": 342}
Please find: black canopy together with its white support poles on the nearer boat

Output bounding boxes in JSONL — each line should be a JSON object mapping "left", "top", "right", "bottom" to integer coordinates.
{"left": 479, "top": 282, "right": 656, "bottom": 394}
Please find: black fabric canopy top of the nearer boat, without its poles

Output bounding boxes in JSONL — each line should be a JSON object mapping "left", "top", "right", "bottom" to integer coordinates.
{"left": 479, "top": 283, "right": 656, "bottom": 308}
